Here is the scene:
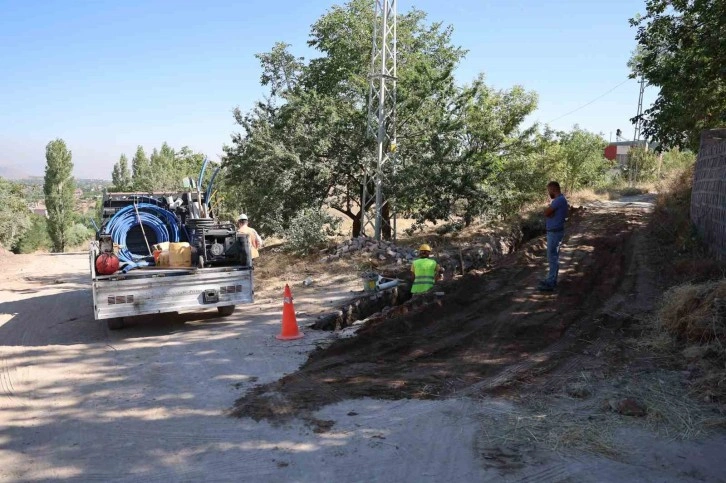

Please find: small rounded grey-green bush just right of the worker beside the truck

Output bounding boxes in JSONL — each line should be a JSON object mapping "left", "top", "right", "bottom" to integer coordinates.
{"left": 281, "top": 208, "right": 340, "bottom": 255}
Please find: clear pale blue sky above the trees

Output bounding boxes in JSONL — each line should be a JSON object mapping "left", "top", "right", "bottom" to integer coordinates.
{"left": 0, "top": 0, "right": 657, "bottom": 179}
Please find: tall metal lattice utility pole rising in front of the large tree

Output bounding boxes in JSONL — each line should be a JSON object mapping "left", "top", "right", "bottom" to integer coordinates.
{"left": 361, "top": 0, "right": 397, "bottom": 240}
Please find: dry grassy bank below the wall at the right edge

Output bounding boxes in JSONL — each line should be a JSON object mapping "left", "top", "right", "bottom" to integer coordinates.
{"left": 643, "top": 167, "right": 726, "bottom": 407}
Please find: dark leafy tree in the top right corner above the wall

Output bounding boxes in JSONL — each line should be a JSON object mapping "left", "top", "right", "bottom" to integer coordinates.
{"left": 630, "top": 0, "right": 726, "bottom": 151}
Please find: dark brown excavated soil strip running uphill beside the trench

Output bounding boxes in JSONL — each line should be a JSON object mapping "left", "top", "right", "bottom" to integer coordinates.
{"left": 231, "top": 207, "right": 645, "bottom": 421}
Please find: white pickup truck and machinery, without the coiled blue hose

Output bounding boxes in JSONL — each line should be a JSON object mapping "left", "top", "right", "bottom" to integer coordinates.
{"left": 90, "top": 193, "right": 254, "bottom": 329}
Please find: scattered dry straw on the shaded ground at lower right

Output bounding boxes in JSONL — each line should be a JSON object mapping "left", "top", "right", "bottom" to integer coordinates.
{"left": 481, "top": 371, "right": 726, "bottom": 459}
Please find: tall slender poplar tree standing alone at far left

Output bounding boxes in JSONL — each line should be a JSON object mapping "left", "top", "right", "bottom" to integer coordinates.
{"left": 43, "top": 139, "right": 75, "bottom": 252}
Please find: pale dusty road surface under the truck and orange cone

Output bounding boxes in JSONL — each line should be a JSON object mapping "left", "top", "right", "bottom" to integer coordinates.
{"left": 0, "top": 199, "right": 726, "bottom": 482}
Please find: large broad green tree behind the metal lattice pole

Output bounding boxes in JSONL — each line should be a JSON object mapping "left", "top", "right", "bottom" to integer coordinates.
{"left": 224, "top": 0, "right": 536, "bottom": 236}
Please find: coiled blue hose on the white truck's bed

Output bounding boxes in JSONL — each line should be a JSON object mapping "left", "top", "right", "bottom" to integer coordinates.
{"left": 106, "top": 203, "right": 180, "bottom": 272}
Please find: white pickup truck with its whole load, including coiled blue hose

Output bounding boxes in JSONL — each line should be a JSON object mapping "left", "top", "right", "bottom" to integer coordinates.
{"left": 90, "top": 164, "right": 254, "bottom": 329}
